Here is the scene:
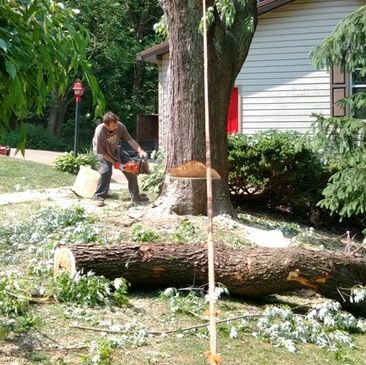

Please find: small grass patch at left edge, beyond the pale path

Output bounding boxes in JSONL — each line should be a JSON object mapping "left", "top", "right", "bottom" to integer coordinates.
{"left": 0, "top": 156, "right": 75, "bottom": 194}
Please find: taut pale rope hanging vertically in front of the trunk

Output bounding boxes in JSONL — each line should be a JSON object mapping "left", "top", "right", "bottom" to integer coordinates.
{"left": 202, "top": 0, "right": 217, "bottom": 364}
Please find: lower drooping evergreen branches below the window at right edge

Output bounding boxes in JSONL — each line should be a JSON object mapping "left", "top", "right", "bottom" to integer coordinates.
{"left": 313, "top": 115, "right": 366, "bottom": 228}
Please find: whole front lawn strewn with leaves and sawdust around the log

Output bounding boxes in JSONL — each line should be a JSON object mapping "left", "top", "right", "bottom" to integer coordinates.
{"left": 0, "top": 157, "right": 366, "bottom": 365}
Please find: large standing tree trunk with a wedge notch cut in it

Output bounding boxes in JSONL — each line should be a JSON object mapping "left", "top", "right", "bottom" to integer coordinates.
{"left": 159, "top": 0, "right": 257, "bottom": 214}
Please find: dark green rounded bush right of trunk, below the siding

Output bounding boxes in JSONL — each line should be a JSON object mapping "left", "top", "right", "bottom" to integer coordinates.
{"left": 229, "top": 131, "right": 330, "bottom": 215}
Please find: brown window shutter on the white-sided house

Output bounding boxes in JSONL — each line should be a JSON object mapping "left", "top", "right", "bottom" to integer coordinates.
{"left": 331, "top": 65, "right": 348, "bottom": 117}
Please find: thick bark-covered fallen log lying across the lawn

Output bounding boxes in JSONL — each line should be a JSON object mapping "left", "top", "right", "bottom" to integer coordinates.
{"left": 54, "top": 244, "right": 366, "bottom": 315}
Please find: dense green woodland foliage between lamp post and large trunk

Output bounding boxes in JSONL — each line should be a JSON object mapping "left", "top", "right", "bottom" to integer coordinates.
{"left": 72, "top": 0, "right": 162, "bottom": 131}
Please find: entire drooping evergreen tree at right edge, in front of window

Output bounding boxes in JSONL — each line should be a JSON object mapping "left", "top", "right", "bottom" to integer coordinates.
{"left": 311, "top": 6, "right": 366, "bottom": 230}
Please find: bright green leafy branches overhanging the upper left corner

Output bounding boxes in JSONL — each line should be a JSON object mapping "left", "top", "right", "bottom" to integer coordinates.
{"left": 0, "top": 0, "right": 104, "bottom": 148}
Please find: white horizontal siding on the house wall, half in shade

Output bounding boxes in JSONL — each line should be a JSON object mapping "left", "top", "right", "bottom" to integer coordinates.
{"left": 236, "top": 0, "right": 366, "bottom": 134}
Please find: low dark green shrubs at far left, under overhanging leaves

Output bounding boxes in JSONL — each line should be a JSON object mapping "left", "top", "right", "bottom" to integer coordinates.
{"left": 0, "top": 124, "right": 67, "bottom": 151}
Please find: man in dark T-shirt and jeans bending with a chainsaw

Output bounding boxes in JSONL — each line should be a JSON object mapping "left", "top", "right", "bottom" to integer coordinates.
{"left": 93, "top": 112, "right": 149, "bottom": 207}
